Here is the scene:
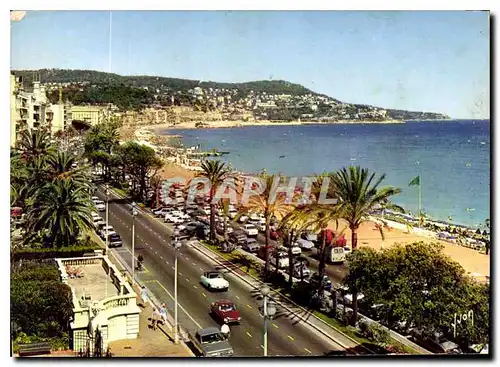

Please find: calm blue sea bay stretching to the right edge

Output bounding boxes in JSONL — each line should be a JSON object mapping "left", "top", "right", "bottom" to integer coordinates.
{"left": 161, "top": 120, "right": 491, "bottom": 227}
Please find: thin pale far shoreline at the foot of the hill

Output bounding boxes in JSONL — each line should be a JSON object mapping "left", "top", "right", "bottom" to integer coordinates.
{"left": 143, "top": 120, "right": 405, "bottom": 133}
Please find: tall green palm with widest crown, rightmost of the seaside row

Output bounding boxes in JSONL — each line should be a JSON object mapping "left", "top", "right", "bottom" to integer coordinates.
{"left": 330, "top": 166, "right": 404, "bottom": 323}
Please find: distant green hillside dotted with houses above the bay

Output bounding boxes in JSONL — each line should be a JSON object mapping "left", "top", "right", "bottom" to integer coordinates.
{"left": 13, "top": 69, "right": 449, "bottom": 122}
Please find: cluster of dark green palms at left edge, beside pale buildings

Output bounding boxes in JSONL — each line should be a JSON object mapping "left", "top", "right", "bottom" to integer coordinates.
{"left": 10, "top": 129, "right": 93, "bottom": 247}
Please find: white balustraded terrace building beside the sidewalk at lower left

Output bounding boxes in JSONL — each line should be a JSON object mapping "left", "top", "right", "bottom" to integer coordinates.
{"left": 56, "top": 255, "right": 140, "bottom": 352}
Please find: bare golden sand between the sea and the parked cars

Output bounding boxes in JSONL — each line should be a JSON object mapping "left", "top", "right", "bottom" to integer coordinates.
{"left": 161, "top": 163, "right": 490, "bottom": 281}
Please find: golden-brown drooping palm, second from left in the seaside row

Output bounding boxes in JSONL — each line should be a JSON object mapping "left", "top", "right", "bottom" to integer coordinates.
{"left": 235, "top": 170, "right": 293, "bottom": 277}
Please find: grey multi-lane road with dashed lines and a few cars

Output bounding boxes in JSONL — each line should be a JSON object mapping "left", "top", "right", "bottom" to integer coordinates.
{"left": 98, "top": 193, "right": 343, "bottom": 356}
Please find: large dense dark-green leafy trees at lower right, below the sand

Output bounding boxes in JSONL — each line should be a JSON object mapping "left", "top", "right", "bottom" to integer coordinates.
{"left": 344, "top": 242, "right": 489, "bottom": 350}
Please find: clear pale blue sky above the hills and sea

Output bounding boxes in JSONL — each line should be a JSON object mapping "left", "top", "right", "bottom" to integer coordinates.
{"left": 11, "top": 11, "right": 490, "bottom": 118}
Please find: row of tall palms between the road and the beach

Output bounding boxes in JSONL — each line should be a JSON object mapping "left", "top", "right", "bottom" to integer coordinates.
{"left": 199, "top": 160, "right": 403, "bottom": 320}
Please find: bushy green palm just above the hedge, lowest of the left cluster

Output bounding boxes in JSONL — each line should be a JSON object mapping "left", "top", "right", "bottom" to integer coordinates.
{"left": 25, "top": 180, "right": 92, "bottom": 247}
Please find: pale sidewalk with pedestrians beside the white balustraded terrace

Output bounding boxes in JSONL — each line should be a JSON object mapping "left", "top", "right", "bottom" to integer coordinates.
{"left": 109, "top": 289, "right": 195, "bottom": 357}
